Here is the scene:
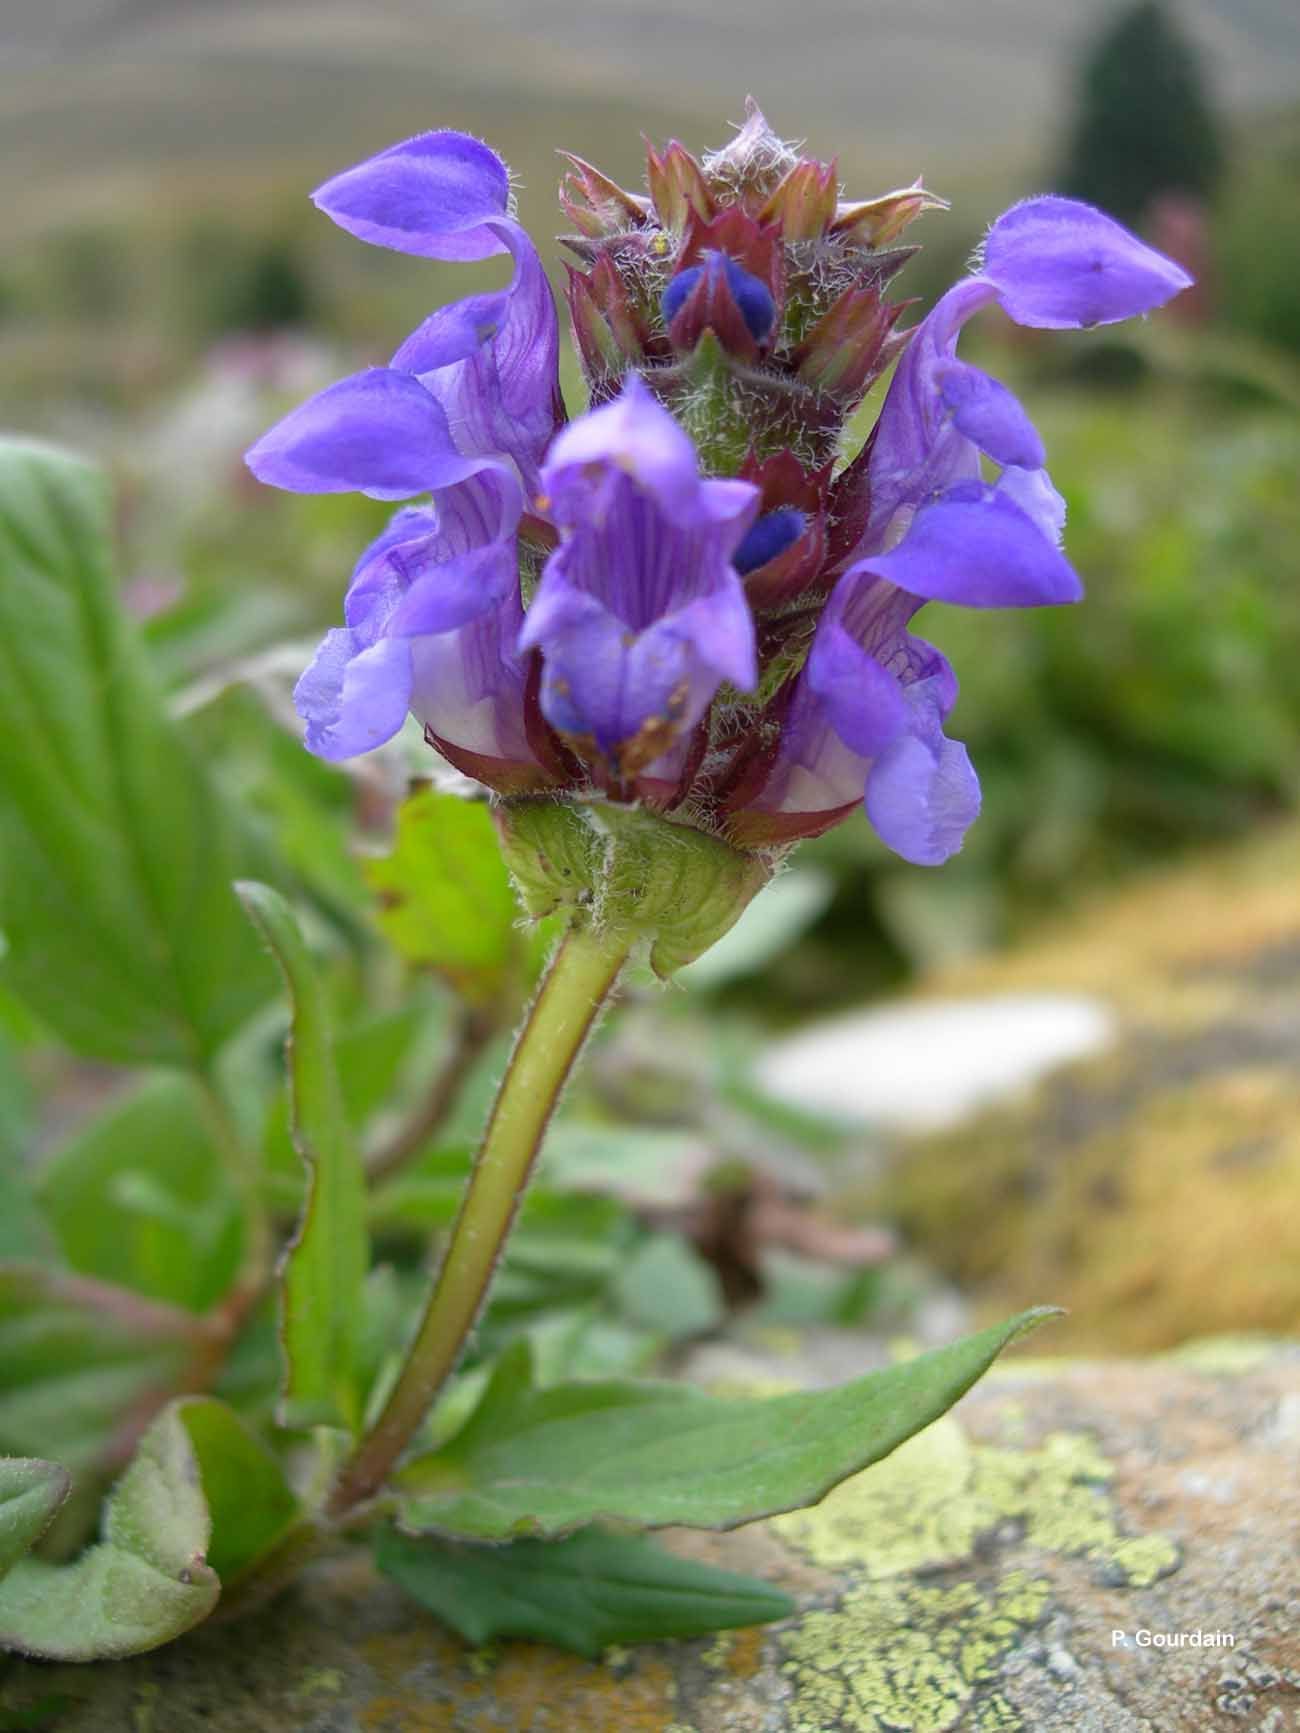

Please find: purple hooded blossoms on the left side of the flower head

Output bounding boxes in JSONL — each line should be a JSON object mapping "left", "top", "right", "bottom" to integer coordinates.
{"left": 248, "top": 132, "right": 560, "bottom": 783}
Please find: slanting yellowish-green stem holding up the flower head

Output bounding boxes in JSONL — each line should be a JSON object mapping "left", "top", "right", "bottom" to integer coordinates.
{"left": 328, "top": 924, "right": 627, "bottom": 1516}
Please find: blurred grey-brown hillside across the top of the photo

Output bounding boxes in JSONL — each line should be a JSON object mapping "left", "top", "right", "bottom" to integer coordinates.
{"left": 0, "top": 0, "right": 1300, "bottom": 237}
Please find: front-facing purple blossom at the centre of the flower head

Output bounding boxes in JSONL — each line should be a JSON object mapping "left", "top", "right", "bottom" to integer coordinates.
{"left": 520, "top": 384, "right": 757, "bottom": 778}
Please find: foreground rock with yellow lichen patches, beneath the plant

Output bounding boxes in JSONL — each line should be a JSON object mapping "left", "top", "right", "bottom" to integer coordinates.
{"left": 0, "top": 1343, "right": 1300, "bottom": 1733}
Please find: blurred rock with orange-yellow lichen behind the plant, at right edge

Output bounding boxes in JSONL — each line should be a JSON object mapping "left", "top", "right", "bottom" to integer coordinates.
{"left": 860, "top": 827, "right": 1300, "bottom": 1353}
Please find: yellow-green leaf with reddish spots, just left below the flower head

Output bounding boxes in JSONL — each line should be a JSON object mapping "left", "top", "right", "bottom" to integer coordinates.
{"left": 366, "top": 789, "right": 534, "bottom": 1005}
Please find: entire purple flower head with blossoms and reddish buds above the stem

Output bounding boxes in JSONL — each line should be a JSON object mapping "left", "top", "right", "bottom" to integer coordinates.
{"left": 248, "top": 104, "right": 1187, "bottom": 865}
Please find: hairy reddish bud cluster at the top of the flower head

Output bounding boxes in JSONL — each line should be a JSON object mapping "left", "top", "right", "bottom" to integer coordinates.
{"left": 562, "top": 102, "right": 943, "bottom": 488}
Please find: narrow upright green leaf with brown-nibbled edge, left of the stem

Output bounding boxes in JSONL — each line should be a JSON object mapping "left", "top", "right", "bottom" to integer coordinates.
{"left": 237, "top": 882, "right": 369, "bottom": 1428}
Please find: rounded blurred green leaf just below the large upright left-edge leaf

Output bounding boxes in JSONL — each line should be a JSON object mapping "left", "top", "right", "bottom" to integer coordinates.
{"left": 35, "top": 1076, "right": 243, "bottom": 1312}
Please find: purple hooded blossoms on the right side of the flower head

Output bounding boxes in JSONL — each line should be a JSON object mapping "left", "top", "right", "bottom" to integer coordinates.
{"left": 731, "top": 199, "right": 1187, "bottom": 867}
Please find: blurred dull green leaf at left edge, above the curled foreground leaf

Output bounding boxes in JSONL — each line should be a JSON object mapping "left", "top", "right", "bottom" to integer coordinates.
{"left": 0, "top": 1263, "right": 194, "bottom": 1471}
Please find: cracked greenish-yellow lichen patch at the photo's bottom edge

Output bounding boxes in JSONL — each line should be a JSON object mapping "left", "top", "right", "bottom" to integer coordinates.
{"left": 782, "top": 1572, "right": 1049, "bottom": 1733}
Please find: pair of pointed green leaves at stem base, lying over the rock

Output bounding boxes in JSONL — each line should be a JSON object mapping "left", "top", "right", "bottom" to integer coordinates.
{"left": 376, "top": 1312, "right": 1047, "bottom": 1657}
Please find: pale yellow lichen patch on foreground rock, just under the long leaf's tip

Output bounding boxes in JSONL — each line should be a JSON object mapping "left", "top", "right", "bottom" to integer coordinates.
{"left": 771, "top": 1418, "right": 1179, "bottom": 1587}
